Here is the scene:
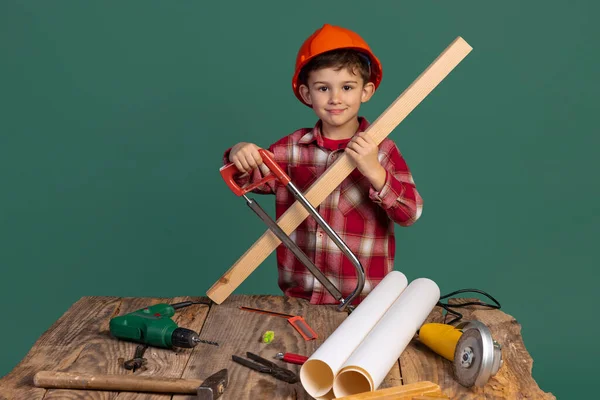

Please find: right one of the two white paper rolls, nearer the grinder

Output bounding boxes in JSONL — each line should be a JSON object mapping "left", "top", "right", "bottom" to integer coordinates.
{"left": 333, "top": 278, "right": 440, "bottom": 397}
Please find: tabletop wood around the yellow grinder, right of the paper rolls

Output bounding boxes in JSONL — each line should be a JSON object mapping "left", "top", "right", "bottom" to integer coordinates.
{"left": 400, "top": 299, "right": 556, "bottom": 400}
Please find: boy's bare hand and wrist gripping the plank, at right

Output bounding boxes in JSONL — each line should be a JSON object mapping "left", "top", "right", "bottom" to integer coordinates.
{"left": 345, "top": 132, "right": 386, "bottom": 191}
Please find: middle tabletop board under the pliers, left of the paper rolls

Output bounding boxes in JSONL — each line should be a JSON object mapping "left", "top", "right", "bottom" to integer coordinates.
{"left": 173, "top": 296, "right": 366, "bottom": 400}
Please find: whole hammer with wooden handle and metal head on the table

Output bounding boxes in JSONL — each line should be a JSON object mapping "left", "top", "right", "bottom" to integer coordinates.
{"left": 33, "top": 369, "right": 228, "bottom": 400}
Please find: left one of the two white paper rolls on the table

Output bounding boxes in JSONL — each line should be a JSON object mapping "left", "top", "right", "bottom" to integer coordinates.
{"left": 300, "top": 271, "right": 408, "bottom": 398}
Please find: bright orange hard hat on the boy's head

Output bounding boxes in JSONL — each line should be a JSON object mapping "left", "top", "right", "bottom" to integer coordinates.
{"left": 292, "top": 24, "right": 383, "bottom": 104}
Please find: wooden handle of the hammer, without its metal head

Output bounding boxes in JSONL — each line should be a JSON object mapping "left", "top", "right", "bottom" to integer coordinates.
{"left": 33, "top": 371, "right": 202, "bottom": 394}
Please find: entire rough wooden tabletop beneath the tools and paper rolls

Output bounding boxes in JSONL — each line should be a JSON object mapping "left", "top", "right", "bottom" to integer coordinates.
{"left": 0, "top": 295, "right": 555, "bottom": 400}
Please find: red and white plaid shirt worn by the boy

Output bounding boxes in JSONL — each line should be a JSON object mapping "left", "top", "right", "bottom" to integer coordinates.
{"left": 223, "top": 117, "right": 423, "bottom": 305}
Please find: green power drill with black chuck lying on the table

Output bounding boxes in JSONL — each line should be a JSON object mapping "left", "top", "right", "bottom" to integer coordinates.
{"left": 110, "top": 301, "right": 219, "bottom": 349}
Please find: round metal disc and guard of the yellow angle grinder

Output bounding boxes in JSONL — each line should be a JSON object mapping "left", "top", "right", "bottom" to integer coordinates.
{"left": 453, "top": 321, "right": 502, "bottom": 387}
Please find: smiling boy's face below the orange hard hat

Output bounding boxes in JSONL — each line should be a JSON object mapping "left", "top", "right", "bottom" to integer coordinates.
{"left": 300, "top": 67, "right": 375, "bottom": 133}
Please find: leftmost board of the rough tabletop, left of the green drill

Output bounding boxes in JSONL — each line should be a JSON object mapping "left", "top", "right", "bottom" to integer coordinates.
{"left": 0, "top": 297, "right": 120, "bottom": 400}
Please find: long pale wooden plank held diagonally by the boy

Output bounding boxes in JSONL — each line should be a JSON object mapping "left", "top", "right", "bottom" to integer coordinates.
{"left": 207, "top": 37, "right": 472, "bottom": 304}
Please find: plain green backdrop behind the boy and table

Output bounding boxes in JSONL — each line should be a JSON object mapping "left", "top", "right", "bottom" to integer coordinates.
{"left": 0, "top": 0, "right": 600, "bottom": 398}
